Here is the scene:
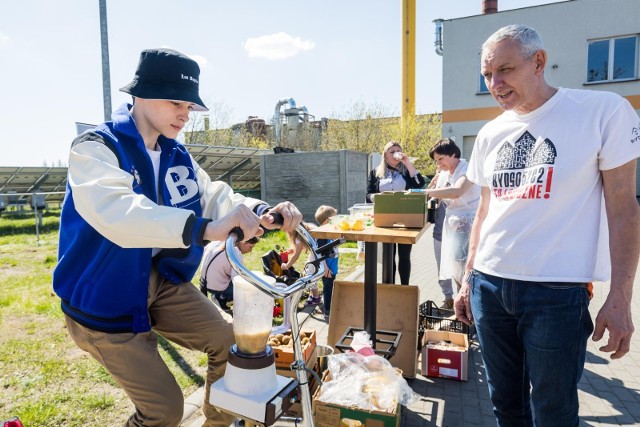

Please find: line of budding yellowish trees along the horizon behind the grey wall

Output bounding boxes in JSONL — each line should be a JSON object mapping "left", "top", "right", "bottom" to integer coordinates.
{"left": 182, "top": 101, "right": 442, "bottom": 175}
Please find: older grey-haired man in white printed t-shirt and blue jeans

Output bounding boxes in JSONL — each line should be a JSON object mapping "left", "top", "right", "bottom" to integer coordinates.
{"left": 455, "top": 25, "right": 640, "bottom": 427}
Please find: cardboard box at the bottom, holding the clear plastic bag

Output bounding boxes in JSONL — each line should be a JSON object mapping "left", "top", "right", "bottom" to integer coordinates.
{"left": 313, "top": 371, "right": 402, "bottom": 427}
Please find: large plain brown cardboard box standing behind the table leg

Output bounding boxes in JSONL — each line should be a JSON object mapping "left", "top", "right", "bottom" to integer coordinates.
{"left": 327, "top": 280, "right": 420, "bottom": 378}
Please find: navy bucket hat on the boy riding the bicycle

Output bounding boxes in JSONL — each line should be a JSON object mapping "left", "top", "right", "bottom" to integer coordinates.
{"left": 120, "top": 49, "right": 208, "bottom": 111}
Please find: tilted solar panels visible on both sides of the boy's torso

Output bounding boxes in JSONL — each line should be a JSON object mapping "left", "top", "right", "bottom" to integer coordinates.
{"left": 0, "top": 144, "right": 272, "bottom": 203}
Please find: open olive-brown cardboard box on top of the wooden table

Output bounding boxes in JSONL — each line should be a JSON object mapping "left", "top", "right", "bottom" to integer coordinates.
{"left": 373, "top": 191, "right": 427, "bottom": 228}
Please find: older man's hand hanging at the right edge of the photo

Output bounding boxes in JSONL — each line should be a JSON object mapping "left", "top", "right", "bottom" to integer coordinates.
{"left": 592, "top": 293, "right": 634, "bottom": 359}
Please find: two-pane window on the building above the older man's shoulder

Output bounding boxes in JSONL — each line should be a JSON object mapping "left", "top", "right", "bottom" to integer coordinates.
{"left": 587, "top": 36, "right": 638, "bottom": 82}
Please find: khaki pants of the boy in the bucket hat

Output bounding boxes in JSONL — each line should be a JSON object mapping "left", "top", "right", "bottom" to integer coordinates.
{"left": 65, "top": 270, "right": 235, "bottom": 427}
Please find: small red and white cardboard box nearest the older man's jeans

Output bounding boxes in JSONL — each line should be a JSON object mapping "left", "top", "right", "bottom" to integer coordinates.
{"left": 422, "top": 330, "right": 469, "bottom": 381}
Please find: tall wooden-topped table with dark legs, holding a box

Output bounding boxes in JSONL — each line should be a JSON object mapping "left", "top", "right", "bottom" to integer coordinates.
{"left": 309, "top": 224, "right": 428, "bottom": 346}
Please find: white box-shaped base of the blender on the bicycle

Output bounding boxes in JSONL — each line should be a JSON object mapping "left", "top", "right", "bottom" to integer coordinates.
{"left": 209, "top": 375, "right": 298, "bottom": 426}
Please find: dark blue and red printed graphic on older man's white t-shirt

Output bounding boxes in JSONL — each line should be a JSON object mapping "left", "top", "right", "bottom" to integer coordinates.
{"left": 491, "top": 132, "right": 558, "bottom": 200}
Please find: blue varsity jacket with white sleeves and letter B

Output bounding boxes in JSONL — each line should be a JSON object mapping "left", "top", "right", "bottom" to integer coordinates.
{"left": 53, "top": 104, "right": 267, "bottom": 333}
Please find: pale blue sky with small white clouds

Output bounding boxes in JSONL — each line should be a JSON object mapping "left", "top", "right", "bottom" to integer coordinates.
{"left": 0, "top": 0, "right": 558, "bottom": 166}
